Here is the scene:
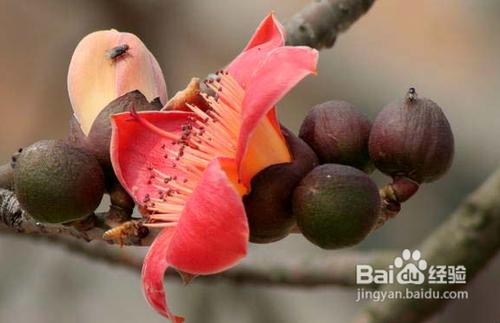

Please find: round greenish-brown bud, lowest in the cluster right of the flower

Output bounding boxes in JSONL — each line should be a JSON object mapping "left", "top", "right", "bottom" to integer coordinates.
{"left": 293, "top": 164, "right": 380, "bottom": 249}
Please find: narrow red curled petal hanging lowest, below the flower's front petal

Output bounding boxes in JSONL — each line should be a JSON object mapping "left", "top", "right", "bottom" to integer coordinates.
{"left": 142, "top": 228, "right": 184, "bottom": 323}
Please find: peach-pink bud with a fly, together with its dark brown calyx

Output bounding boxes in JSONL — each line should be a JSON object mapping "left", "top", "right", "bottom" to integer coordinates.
{"left": 68, "top": 29, "right": 167, "bottom": 178}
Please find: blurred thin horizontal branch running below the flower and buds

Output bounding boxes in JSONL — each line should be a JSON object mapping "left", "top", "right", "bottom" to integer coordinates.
{"left": 0, "top": 227, "right": 396, "bottom": 288}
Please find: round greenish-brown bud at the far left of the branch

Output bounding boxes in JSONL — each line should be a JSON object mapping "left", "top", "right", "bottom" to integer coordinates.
{"left": 14, "top": 140, "right": 104, "bottom": 223}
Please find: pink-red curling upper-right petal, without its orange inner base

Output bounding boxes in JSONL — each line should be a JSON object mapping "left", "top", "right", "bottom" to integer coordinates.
{"left": 236, "top": 46, "right": 318, "bottom": 183}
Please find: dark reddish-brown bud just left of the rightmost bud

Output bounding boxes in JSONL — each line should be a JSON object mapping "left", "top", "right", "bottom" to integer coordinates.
{"left": 299, "top": 101, "right": 373, "bottom": 172}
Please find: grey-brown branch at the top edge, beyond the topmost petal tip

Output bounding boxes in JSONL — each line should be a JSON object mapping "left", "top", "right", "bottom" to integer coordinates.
{"left": 286, "top": 0, "right": 375, "bottom": 49}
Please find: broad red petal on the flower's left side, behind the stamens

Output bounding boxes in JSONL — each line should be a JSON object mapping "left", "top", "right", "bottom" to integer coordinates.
{"left": 111, "top": 111, "right": 193, "bottom": 204}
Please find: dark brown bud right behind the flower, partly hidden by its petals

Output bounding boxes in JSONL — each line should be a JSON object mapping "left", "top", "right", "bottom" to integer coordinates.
{"left": 243, "top": 128, "right": 318, "bottom": 243}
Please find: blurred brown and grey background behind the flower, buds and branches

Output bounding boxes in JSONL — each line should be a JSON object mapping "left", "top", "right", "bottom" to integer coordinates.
{"left": 0, "top": 0, "right": 500, "bottom": 323}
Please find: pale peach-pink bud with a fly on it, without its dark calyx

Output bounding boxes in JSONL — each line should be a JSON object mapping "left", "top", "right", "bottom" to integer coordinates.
{"left": 68, "top": 29, "right": 167, "bottom": 135}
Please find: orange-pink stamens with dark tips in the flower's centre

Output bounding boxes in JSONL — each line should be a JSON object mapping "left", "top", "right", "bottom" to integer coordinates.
{"left": 135, "top": 72, "right": 245, "bottom": 227}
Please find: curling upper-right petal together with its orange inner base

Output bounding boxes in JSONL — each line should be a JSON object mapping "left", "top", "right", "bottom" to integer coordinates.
{"left": 236, "top": 46, "right": 318, "bottom": 183}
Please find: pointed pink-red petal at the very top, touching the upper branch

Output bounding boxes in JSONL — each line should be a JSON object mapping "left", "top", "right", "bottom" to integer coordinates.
{"left": 226, "top": 14, "right": 285, "bottom": 88}
